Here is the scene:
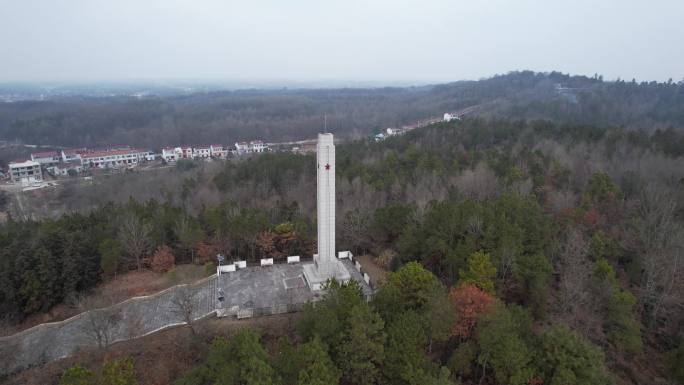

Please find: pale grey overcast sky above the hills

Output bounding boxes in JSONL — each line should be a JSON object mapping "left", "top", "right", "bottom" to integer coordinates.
{"left": 0, "top": 0, "right": 684, "bottom": 82}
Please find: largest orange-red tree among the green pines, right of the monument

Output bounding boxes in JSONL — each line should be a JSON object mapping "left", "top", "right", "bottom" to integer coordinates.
{"left": 449, "top": 284, "right": 496, "bottom": 340}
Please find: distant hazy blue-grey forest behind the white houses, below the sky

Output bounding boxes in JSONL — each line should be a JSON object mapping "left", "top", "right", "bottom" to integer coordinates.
{"left": 0, "top": 71, "right": 684, "bottom": 151}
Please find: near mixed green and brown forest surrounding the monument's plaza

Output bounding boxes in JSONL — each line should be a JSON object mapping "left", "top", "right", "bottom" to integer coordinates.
{"left": 0, "top": 112, "right": 684, "bottom": 384}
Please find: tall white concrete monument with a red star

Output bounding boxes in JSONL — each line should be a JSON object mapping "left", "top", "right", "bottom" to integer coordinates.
{"left": 304, "top": 134, "right": 351, "bottom": 290}
